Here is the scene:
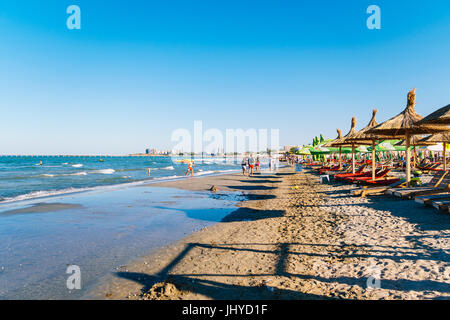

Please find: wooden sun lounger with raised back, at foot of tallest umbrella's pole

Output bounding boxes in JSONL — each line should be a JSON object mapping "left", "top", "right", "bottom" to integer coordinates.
{"left": 386, "top": 171, "right": 450, "bottom": 199}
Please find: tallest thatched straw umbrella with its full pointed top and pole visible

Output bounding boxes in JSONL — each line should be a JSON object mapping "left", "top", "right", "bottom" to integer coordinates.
{"left": 368, "top": 88, "right": 447, "bottom": 185}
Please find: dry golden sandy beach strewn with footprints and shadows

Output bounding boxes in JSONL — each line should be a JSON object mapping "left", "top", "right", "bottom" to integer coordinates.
{"left": 87, "top": 167, "right": 450, "bottom": 300}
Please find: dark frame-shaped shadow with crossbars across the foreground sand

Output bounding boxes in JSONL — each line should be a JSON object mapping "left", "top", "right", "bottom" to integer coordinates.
{"left": 116, "top": 243, "right": 450, "bottom": 300}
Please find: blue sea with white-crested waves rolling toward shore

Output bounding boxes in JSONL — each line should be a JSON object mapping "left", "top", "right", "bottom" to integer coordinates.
{"left": 0, "top": 156, "right": 246, "bottom": 203}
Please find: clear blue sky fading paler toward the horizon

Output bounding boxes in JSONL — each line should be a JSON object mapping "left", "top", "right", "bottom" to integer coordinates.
{"left": 0, "top": 0, "right": 450, "bottom": 154}
